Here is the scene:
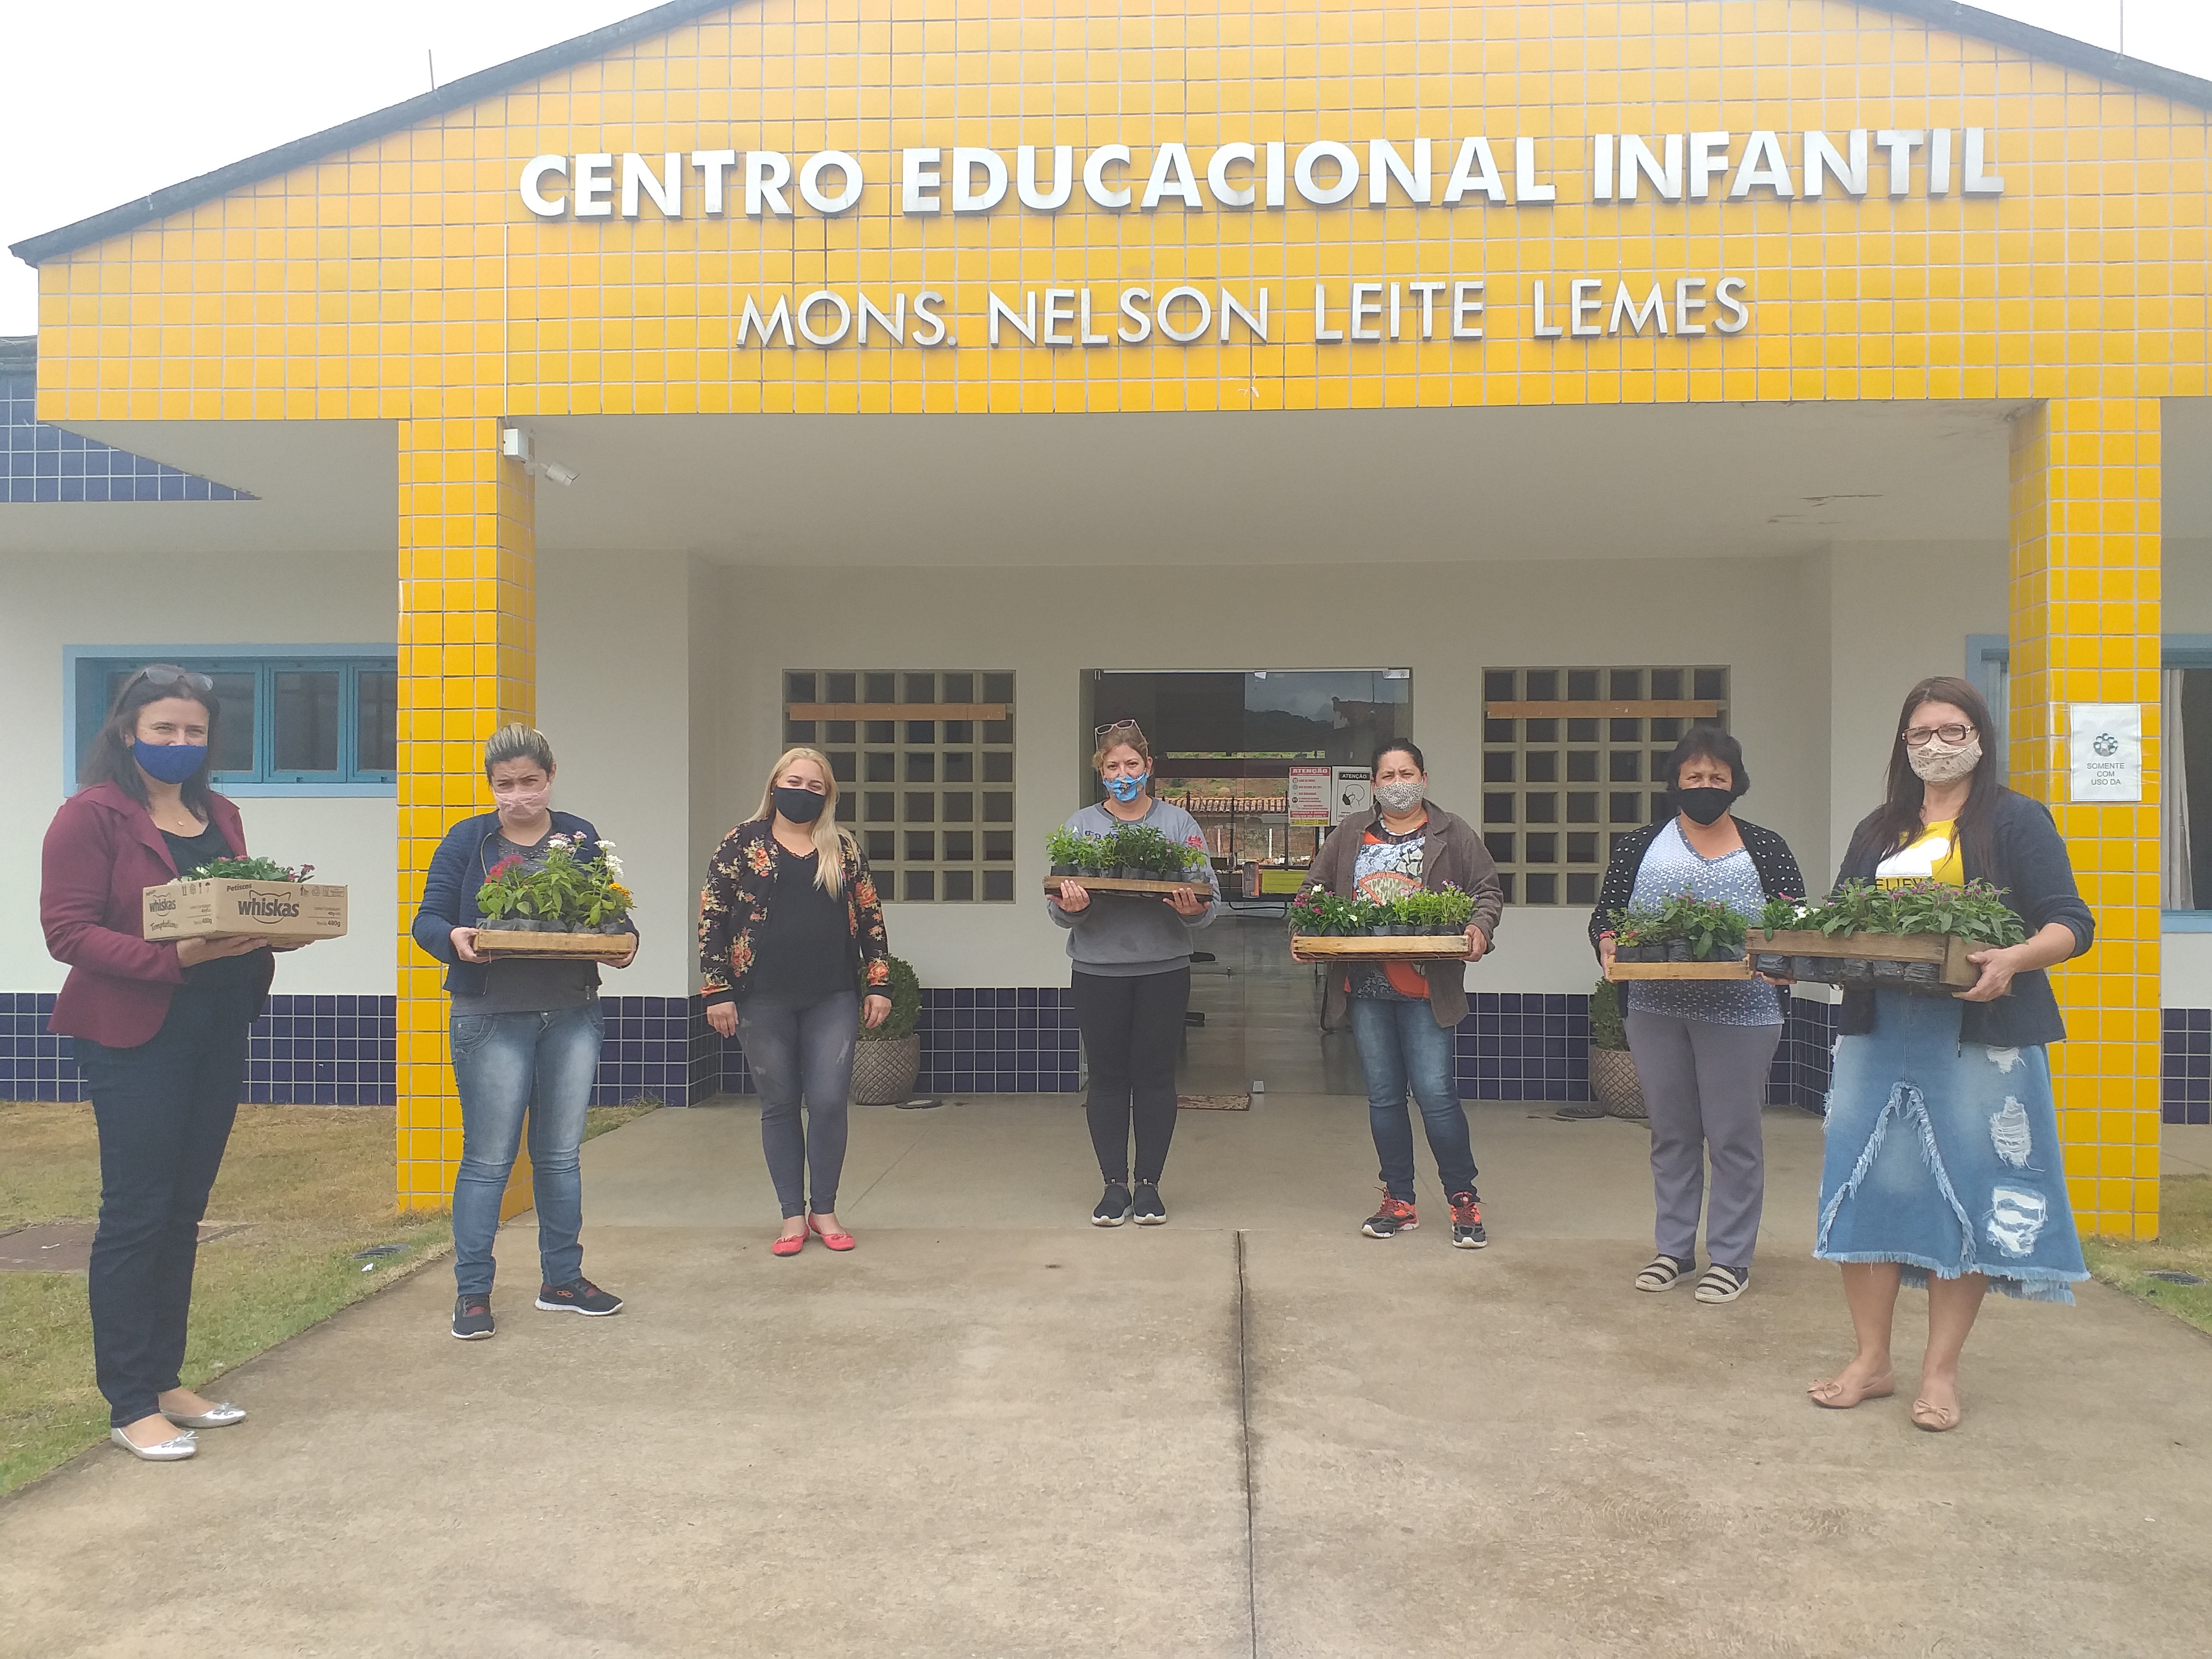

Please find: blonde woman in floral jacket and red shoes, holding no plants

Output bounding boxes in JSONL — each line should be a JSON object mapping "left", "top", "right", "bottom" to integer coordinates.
{"left": 699, "top": 748, "right": 892, "bottom": 1257}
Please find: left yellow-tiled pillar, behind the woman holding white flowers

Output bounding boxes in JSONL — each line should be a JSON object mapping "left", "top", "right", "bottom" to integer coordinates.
{"left": 396, "top": 416, "right": 537, "bottom": 1214}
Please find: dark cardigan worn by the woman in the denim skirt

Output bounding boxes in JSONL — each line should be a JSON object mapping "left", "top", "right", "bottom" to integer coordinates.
{"left": 1836, "top": 790, "right": 2097, "bottom": 1049}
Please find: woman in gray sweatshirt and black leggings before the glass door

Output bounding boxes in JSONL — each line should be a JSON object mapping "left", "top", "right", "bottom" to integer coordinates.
{"left": 1047, "top": 721, "right": 1219, "bottom": 1228}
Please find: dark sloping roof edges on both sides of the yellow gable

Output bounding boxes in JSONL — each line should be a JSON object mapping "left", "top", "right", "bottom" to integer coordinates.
{"left": 9, "top": 0, "right": 2212, "bottom": 265}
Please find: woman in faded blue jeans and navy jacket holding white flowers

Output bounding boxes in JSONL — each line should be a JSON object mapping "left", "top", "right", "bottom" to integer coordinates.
{"left": 414, "top": 723, "right": 637, "bottom": 1343}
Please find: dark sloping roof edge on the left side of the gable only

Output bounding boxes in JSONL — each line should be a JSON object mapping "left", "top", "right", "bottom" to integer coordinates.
{"left": 9, "top": 0, "right": 741, "bottom": 265}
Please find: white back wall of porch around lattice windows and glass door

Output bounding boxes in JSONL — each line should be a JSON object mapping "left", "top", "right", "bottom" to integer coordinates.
{"left": 694, "top": 559, "right": 1831, "bottom": 991}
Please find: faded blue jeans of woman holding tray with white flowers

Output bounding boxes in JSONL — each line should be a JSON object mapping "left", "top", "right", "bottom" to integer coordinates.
{"left": 451, "top": 998, "right": 602, "bottom": 1296}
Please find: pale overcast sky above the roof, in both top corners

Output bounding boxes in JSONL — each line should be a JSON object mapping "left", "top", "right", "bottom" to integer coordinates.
{"left": 0, "top": 0, "right": 2212, "bottom": 334}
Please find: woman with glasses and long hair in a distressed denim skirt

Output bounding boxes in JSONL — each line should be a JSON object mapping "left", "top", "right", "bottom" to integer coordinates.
{"left": 1812, "top": 677, "right": 2095, "bottom": 1431}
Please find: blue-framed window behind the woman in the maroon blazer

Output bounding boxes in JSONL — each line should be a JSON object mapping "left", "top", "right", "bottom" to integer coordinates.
{"left": 64, "top": 646, "right": 398, "bottom": 796}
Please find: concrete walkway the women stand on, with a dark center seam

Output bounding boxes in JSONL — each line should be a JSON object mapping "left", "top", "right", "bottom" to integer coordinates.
{"left": 0, "top": 1097, "right": 2212, "bottom": 1659}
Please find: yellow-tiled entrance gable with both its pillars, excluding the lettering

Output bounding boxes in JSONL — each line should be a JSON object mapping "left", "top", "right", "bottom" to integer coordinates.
{"left": 21, "top": 0, "right": 2212, "bottom": 1232}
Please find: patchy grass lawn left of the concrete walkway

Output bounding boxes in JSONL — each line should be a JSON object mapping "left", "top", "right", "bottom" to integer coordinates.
{"left": 0, "top": 1104, "right": 651, "bottom": 1493}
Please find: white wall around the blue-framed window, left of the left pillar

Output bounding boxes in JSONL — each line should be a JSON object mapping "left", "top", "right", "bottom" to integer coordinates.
{"left": 0, "top": 546, "right": 398, "bottom": 993}
